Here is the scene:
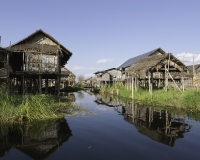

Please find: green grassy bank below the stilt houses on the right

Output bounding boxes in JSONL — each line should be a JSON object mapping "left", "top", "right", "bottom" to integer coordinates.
{"left": 100, "top": 84, "right": 200, "bottom": 112}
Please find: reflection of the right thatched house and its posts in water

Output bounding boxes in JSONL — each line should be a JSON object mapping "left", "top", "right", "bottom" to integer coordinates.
{"left": 122, "top": 104, "right": 191, "bottom": 147}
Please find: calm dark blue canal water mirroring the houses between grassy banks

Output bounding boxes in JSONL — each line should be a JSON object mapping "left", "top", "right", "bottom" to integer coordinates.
{"left": 0, "top": 92, "right": 200, "bottom": 160}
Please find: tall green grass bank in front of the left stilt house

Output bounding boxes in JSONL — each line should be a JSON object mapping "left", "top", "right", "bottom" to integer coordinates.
{"left": 0, "top": 92, "right": 85, "bottom": 122}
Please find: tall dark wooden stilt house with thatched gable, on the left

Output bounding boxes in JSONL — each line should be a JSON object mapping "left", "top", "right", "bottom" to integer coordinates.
{"left": 4, "top": 30, "right": 72, "bottom": 94}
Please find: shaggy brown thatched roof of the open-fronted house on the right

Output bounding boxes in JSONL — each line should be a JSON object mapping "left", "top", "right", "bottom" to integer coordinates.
{"left": 127, "top": 54, "right": 187, "bottom": 73}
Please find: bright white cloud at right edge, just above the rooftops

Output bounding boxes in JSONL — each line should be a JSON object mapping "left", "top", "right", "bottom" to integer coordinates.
{"left": 176, "top": 53, "right": 200, "bottom": 65}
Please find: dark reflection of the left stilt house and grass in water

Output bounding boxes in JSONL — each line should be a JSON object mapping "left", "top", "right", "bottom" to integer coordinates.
{"left": 0, "top": 118, "right": 72, "bottom": 159}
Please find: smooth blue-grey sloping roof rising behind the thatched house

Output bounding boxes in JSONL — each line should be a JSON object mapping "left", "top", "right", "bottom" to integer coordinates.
{"left": 117, "top": 48, "right": 166, "bottom": 69}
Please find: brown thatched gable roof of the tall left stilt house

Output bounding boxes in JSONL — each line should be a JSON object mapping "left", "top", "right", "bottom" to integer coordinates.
{"left": 6, "top": 29, "right": 72, "bottom": 66}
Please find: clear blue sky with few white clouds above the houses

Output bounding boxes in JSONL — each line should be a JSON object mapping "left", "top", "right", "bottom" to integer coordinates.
{"left": 0, "top": 0, "right": 200, "bottom": 78}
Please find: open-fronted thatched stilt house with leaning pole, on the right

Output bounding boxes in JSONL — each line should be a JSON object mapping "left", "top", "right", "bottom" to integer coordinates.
{"left": 125, "top": 53, "right": 188, "bottom": 88}
